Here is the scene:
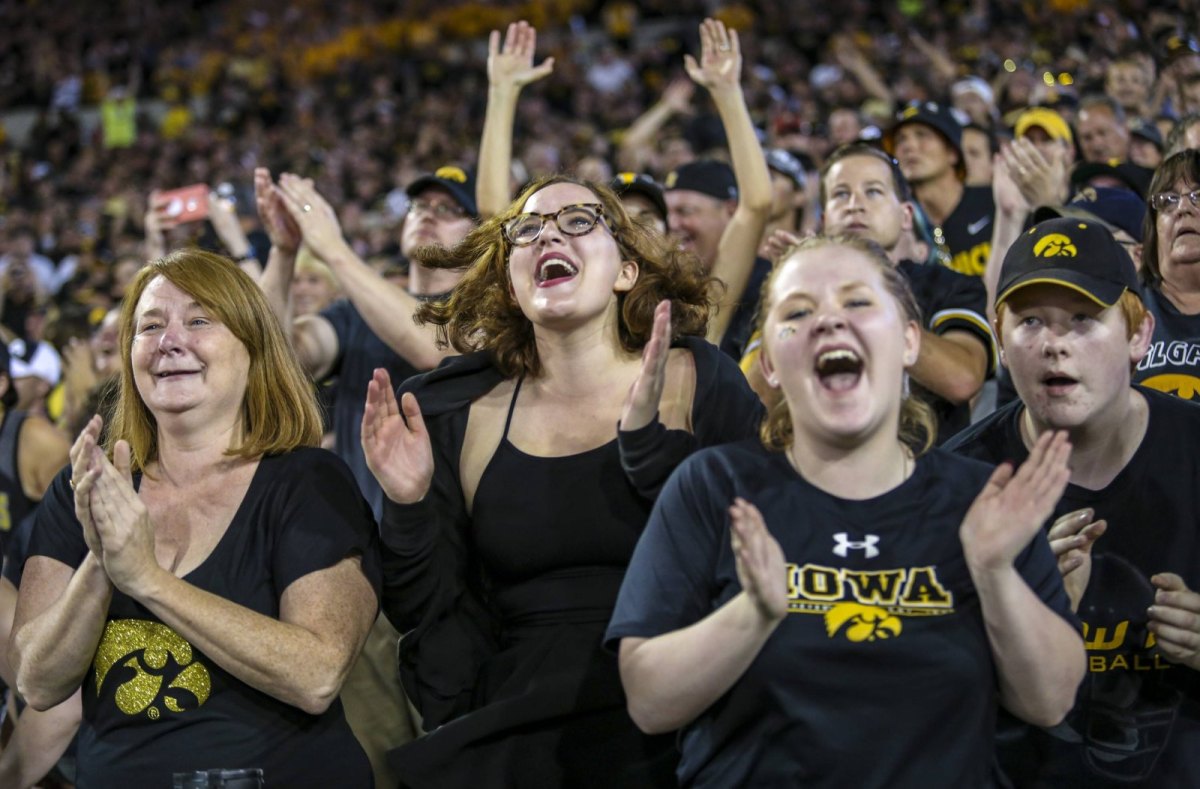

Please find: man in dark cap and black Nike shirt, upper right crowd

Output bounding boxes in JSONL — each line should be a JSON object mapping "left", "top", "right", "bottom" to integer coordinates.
{"left": 883, "top": 102, "right": 996, "bottom": 276}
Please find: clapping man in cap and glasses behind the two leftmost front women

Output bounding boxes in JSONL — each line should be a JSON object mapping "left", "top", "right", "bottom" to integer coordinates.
{"left": 254, "top": 165, "right": 475, "bottom": 785}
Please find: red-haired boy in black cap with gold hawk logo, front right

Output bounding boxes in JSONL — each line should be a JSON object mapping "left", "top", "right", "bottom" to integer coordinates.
{"left": 947, "top": 217, "right": 1200, "bottom": 788}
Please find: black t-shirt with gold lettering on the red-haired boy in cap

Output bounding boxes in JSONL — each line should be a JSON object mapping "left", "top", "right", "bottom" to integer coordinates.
{"left": 947, "top": 387, "right": 1200, "bottom": 787}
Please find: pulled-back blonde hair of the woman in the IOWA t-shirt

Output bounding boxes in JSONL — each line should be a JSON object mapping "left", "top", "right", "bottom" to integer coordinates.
{"left": 758, "top": 236, "right": 937, "bottom": 456}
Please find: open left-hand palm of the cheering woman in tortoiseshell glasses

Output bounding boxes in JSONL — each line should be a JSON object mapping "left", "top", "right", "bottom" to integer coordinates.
{"left": 361, "top": 368, "right": 433, "bottom": 504}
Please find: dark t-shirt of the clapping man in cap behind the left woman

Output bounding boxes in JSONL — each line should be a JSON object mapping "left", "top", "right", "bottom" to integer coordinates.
{"left": 320, "top": 294, "right": 420, "bottom": 520}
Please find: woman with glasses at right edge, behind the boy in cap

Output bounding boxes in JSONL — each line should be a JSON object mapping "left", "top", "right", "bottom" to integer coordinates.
{"left": 1133, "top": 149, "right": 1200, "bottom": 400}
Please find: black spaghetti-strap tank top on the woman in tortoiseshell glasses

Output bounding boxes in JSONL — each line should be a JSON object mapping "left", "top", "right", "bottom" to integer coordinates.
{"left": 473, "top": 378, "right": 650, "bottom": 625}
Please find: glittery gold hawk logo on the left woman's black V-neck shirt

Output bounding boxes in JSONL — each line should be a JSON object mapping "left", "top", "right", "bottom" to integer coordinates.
{"left": 92, "top": 619, "right": 212, "bottom": 721}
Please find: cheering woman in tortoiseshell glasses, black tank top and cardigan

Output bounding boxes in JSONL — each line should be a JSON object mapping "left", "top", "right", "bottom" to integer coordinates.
{"left": 362, "top": 175, "right": 761, "bottom": 788}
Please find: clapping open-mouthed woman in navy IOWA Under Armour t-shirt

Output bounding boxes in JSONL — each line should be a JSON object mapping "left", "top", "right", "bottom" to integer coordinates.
{"left": 605, "top": 236, "right": 1084, "bottom": 787}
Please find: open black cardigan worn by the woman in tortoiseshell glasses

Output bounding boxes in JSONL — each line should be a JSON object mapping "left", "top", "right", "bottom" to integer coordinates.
{"left": 380, "top": 337, "right": 763, "bottom": 730}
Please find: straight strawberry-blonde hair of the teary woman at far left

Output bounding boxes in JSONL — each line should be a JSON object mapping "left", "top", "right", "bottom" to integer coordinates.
{"left": 106, "top": 249, "right": 322, "bottom": 470}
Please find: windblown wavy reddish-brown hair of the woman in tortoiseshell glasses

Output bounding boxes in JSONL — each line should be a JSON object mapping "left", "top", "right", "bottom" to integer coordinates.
{"left": 413, "top": 174, "right": 715, "bottom": 378}
